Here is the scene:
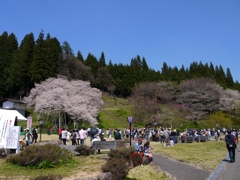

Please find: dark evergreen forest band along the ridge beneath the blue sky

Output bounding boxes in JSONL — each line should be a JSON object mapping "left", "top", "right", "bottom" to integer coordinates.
{"left": 0, "top": 31, "right": 240, "bottom": 99}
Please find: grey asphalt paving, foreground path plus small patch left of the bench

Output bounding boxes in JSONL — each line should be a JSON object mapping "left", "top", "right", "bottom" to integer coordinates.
{"left": 60, "top": 141, "right": 240, "bottom": 180}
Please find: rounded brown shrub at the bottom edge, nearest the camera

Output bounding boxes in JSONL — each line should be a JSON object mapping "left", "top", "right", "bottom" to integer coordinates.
{"left": 102, "top": 158, "right": 129, "bottom": 180}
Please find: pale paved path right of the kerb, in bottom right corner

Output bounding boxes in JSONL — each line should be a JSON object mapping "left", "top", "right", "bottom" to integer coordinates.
{"left": 209, "top": 146, "right": 240, "bottom": 180}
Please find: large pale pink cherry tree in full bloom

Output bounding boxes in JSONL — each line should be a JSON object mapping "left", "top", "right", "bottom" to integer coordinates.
{"left": 24, "top": 76, "right": 103, "bottom": 126}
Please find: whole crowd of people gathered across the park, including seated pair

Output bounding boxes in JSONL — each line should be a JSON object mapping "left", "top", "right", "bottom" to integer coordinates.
{"left": 23, "top": 127, "right": 239, "bottom": 165}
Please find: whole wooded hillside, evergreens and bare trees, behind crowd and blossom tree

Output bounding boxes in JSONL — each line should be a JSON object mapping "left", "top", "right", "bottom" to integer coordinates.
{"left": 0, "top": 31, "right": 240, "bottom": 127}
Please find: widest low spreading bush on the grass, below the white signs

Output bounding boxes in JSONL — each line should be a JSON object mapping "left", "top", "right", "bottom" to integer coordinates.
{"left": 7, "top": 144, "right": 73, "bottom": 169}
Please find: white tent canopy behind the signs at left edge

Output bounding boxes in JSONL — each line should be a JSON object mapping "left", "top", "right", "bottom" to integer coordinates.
{"left": 0, "top": 109, "right": 27, "bottom": 121}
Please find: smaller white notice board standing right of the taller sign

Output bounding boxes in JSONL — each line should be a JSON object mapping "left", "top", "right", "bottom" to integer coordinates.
{"left": 6, "top": 126, "right": 21, "bottom": 149}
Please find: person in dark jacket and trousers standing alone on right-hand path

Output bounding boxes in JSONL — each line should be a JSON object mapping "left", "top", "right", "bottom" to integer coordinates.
{"left": 225, "top": 130, "right": 237, "bottom": 163}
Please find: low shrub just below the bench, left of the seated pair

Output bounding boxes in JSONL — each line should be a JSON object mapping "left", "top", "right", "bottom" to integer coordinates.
{"left": 108, "top": 147, "right": 135, "bottom": 161}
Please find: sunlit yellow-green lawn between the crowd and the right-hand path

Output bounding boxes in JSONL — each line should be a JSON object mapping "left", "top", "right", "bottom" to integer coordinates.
{"left": 151, "top": 141, "right": 227, "bottom": 170}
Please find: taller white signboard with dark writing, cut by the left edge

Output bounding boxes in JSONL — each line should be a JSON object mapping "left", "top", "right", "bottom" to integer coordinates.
{"left": 0, "top": 119, "right": 15, "bottom": 148}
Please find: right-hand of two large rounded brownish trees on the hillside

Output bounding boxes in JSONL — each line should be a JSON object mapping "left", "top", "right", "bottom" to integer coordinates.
{"left": 177, "top": 78, "right": 222, "bottom": 121}
